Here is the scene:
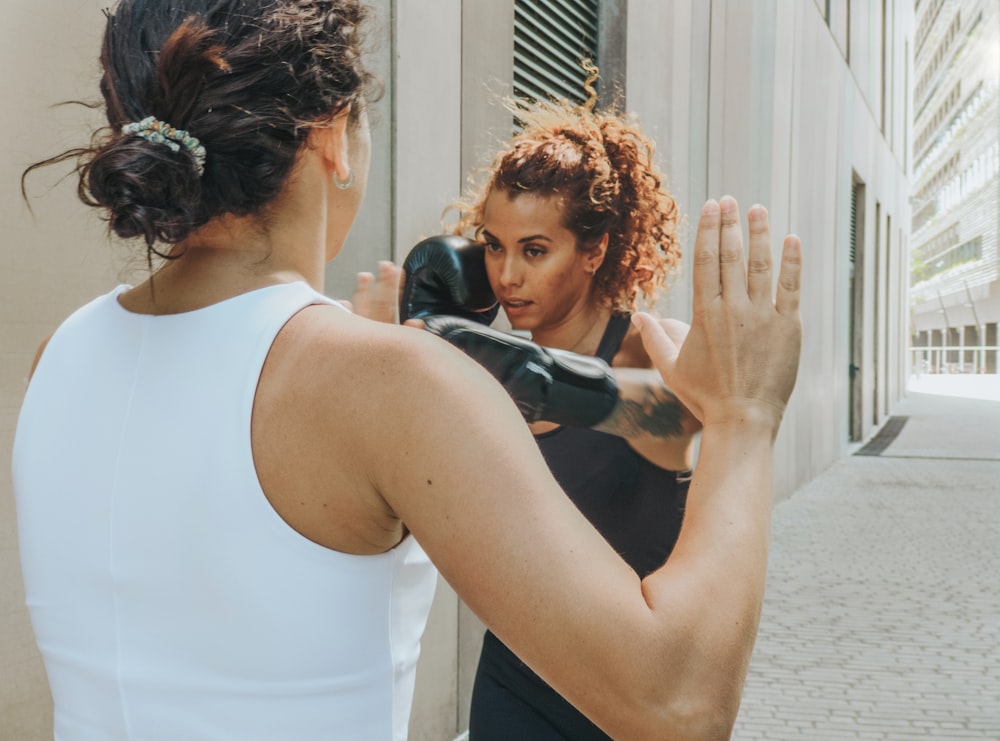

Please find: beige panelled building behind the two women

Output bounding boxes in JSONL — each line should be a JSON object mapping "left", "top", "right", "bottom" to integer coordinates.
{"left": 0, "top": 0, "right": 916, "bottom": 741}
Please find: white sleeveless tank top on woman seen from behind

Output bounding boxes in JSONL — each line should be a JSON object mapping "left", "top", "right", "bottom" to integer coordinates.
{"left": 13, "top": 283, "right": 436, "bottom": 741}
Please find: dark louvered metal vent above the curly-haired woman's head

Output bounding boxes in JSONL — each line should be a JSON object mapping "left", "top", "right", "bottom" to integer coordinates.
{"left": 514, "top": 0, "right": 600, "bottom": 103}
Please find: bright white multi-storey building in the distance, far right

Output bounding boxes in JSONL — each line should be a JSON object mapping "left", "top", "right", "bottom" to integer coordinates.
{"left": 911, "top": 0, "right": 1000, "bottom": 373}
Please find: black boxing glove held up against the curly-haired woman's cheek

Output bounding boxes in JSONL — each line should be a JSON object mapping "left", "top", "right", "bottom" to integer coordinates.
{"left": 399, "top": 234, "right": 500, "bottom": 324}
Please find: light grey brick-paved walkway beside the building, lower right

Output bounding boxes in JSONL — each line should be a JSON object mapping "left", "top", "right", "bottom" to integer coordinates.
{"left": 733, "top": 376, "right": 1000, "bottom": 741}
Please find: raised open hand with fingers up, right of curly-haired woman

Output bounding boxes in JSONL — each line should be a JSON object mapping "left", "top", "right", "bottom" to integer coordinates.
{"left": 636, "top": 197, "right": 802, "bottom": 435}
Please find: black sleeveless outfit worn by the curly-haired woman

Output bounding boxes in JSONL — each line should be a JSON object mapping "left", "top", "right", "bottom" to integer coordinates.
{"left": 470, "top": 314, "right": 690, "bottom": 741}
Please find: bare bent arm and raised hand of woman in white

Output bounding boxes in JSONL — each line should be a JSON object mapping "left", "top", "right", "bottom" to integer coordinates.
{"left": 369, "top": 199, "right": 800, "bottom": 739}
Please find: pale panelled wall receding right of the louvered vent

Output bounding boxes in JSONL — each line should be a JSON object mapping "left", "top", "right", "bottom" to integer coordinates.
{"left": 627, "top": 0, "right": 913, "bottom": 486}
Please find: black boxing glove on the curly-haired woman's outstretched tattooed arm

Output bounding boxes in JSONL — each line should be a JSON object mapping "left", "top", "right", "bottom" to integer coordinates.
{"left": 424, "top": 316, "right": 618, "bottom": 427}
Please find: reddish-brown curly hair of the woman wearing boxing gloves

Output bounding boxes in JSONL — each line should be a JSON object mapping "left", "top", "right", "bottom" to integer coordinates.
{"left": 451, "top": 63, "right": 681, "bottom": 311}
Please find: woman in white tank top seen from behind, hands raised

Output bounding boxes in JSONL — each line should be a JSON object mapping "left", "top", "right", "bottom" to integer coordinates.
{"left": 13, "top": 0, "right": 800, "bottom": 741}
